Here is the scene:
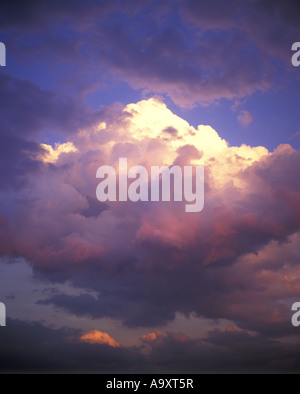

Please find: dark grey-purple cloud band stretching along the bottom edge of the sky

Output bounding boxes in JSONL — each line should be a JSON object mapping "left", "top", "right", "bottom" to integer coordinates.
{"left": 0, "top": 319, "right": 300, "bottom": 373}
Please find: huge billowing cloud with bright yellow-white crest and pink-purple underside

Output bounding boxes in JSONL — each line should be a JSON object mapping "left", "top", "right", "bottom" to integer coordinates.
{"left": 0, "top": 99, "right": 300, "bottom": 354}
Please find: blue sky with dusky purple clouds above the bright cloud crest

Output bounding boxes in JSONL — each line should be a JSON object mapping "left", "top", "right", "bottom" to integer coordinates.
{"left": 2, "top": 1, "right": 300, "bottom": 150}
